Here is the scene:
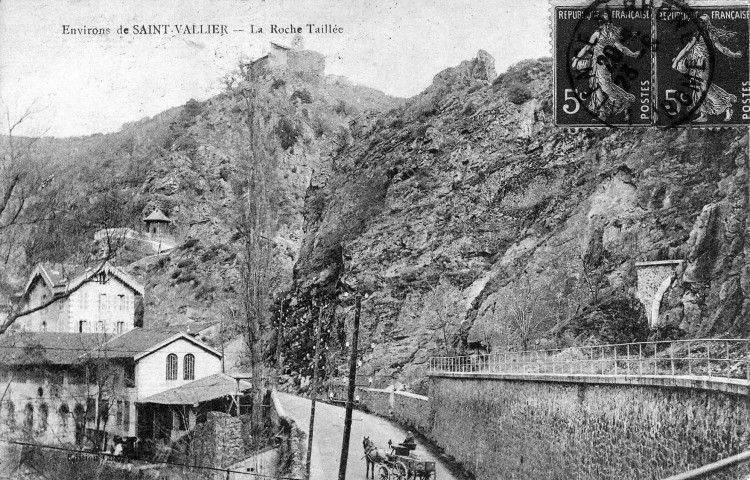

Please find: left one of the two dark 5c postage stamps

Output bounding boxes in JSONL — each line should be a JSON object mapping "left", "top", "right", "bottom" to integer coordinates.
{"left": 553, "top": 1, "right": 653, "bottom": 127}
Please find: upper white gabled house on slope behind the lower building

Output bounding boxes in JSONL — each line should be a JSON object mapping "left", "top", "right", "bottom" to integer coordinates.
{"left": 14, "top": 263, "right": 144, "bottom": 334}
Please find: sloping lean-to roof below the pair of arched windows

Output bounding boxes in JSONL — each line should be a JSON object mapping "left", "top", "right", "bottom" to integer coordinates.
{"left": 138, "top": 373, "right": 252, "bottom": 405}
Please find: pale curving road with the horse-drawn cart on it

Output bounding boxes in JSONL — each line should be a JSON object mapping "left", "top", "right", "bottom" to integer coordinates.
{"left": 278, "top": 393, "right": 458, "bottom": 480}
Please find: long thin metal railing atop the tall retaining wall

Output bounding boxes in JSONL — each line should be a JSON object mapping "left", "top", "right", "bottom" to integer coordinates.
{"left": 429, "top": 339, "right": 750, "bottom": 381}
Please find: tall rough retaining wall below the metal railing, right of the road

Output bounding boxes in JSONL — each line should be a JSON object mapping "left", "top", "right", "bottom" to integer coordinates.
{"left": 427, "top": 377, "right": 750, "bottom": 480}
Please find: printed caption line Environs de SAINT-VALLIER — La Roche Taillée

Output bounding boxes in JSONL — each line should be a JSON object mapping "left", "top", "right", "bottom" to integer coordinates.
{"left": 62, "top": 23, "right": 344, "bottom": 35}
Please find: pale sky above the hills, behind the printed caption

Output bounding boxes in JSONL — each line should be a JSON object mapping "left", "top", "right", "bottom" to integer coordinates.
{"left": 0, "top": 0, "right": 551, "bottom": 137}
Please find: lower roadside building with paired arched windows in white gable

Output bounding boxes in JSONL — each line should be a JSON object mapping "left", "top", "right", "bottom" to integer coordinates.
{"left": 0, "top": 328, "right": 221, "bottom": 446}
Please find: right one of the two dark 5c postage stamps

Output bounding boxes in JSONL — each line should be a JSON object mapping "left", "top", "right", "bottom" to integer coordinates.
{"left": 654, "top": 2, "right": 750, "bottom": 126}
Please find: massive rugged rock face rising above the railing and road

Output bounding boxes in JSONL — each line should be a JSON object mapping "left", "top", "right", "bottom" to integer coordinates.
{"left": 294, "top": 52, "right": 750, "bottom": 386}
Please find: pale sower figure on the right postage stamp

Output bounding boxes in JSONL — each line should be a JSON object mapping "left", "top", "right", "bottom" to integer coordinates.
{"left": 672, "top": 14, "right": 742, "bottom": 122}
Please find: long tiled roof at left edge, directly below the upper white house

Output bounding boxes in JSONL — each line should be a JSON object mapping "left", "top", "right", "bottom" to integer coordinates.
{"left": 0, "top": 332, "right": 107, "bottom": 365}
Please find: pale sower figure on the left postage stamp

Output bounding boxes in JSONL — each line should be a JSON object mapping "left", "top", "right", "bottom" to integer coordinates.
{"left": 573, "top": 9, "right": 640, "bottom": 121}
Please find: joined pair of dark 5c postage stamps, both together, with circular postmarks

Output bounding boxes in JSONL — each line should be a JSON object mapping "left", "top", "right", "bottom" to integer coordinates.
{"left": 552, "top": 0, "right": 750, "bottom": 127}
